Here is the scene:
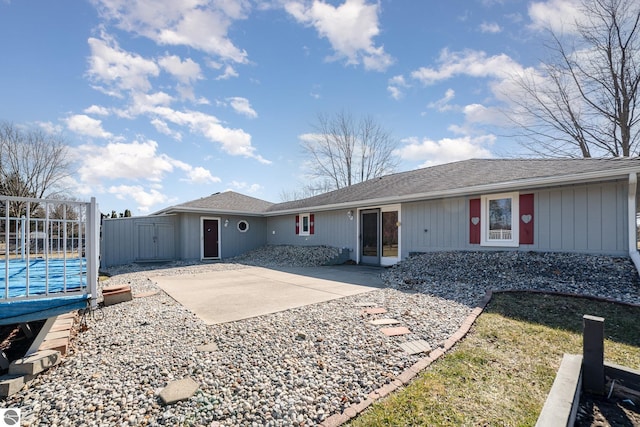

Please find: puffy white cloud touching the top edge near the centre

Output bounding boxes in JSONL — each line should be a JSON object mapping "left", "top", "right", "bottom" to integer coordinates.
{"left": 285, "top": 0, "right": 393, "bottom": 71}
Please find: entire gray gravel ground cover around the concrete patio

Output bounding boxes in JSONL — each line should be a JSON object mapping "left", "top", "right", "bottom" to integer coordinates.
{"left": 3, "top": 247, "right": 640, "bottom": 426}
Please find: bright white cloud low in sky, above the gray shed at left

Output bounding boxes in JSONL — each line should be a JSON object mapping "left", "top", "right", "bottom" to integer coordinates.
{"left": 78, "top": 141, "right": 178, "bottom": 183}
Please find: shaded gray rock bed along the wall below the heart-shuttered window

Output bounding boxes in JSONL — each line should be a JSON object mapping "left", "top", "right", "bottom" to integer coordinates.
{"left": 383, "top": 251, "right": 640, "bottom": 304}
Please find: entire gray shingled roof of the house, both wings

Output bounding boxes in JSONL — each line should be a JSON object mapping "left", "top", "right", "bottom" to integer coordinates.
{"left": 156, "top": 157, "right": 640, "bottom": 215}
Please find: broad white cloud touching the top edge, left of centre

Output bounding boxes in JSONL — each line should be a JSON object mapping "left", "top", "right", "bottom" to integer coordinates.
{"left": 95, "top": 0, "right": 251, "bottom": 63}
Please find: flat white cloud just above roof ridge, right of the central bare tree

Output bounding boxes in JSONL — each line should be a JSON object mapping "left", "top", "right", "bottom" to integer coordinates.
{"left": 394, "top": 135, "right": 496, "bottom": 167}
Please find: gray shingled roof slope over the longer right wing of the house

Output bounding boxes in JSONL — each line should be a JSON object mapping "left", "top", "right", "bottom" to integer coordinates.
{"left": 267, "top": 158, "right": 640, "bottom": 213}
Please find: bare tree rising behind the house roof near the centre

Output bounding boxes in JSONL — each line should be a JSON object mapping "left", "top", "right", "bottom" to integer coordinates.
{"left": 302, "top": 112, "right": 398, "bottom": 190}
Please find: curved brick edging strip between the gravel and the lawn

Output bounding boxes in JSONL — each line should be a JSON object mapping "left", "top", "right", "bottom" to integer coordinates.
{"left": 320, "top": 289, "right": 640, "bottom": 427}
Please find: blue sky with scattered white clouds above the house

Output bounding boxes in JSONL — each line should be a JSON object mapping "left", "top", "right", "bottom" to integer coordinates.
{"left": 0, "top": 0, "right": 577, "bottom": 215}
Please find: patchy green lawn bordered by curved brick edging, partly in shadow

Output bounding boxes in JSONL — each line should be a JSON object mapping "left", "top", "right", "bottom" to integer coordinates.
{"left": 349, "top": 293, "right": 640, "bottom": 426}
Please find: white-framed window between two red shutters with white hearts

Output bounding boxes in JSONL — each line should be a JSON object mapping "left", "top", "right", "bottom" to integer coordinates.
{"left": 480, "top": 193, "right": 520, "bottom": 247}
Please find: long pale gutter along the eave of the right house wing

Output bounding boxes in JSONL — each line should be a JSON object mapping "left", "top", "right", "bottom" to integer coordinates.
{"left": 262, "top": 166, "right": 640, "bottom": 217}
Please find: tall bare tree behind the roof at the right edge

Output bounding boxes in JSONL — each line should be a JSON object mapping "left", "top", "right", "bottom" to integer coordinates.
{"left": 508, "top": 0, "right": 640, "bottom": 157}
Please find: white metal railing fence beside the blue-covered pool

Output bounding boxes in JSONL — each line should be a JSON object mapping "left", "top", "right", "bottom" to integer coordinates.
{"left": 0, "top": 195, "right": 100, "bottom": 305}
